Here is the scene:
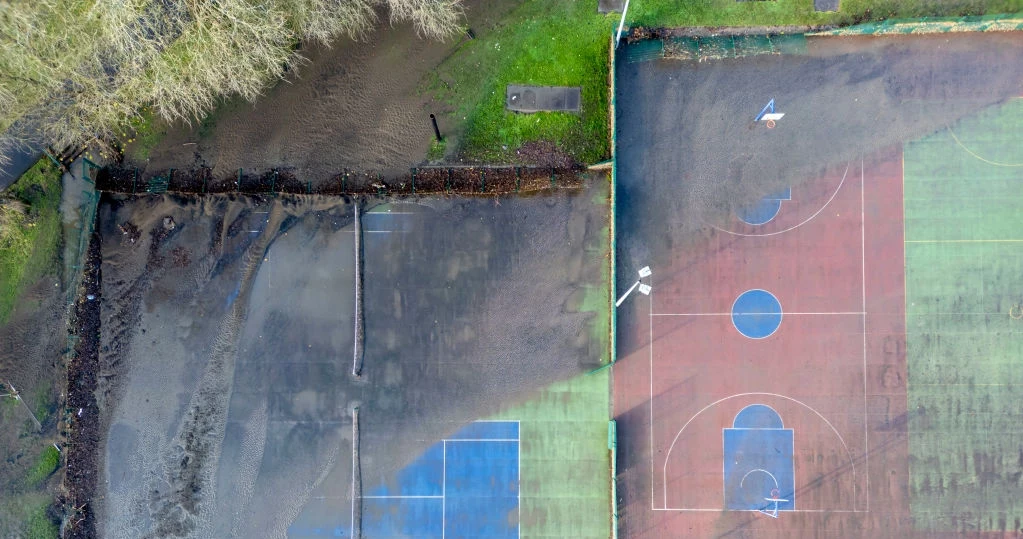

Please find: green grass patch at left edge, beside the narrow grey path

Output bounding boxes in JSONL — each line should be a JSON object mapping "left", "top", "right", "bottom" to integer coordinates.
{"left": 0, "top": 158, "right": 60, "bottom": 323}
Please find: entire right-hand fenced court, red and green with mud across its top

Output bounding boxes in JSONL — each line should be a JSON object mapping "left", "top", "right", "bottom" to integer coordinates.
{"left": 614, "top": 33, "right": 1023, "bottom": 537}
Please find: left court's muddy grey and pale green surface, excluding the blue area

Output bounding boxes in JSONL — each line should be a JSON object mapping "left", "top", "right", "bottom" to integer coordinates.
{"left": 98, "top": 177, "right": 610, "bottom": 537}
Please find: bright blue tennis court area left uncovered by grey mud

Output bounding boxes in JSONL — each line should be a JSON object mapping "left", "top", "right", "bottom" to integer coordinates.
{"left": 362, "top": 421, "right": 520, "bottom": 538}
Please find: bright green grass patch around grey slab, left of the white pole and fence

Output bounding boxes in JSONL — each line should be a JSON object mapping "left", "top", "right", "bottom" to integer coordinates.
{"left": 431, "top": 0, "right": 616, "bottom": 163}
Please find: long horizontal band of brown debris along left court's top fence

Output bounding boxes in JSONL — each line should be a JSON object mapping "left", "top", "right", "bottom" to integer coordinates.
{"left": 96, "top": 166, "right": 584, "bottom": 195}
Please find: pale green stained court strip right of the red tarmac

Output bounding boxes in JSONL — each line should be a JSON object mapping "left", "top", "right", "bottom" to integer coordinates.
{"left": 904, "top": 99, "right": 1023, "bottom": 532}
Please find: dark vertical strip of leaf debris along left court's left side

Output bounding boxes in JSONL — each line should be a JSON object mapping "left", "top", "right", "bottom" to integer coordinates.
{"left": 61, "top": 233, "right": 102, "bottom": 539}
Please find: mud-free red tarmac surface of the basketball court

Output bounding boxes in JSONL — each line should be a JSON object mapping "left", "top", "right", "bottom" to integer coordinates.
{"left": 615, "top": 150, "right": 908, "bottom": 537}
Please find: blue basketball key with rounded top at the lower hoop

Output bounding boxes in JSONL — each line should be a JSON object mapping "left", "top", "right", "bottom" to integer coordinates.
{"left": 722, "top": 404, "right": 796, "bottom": 511}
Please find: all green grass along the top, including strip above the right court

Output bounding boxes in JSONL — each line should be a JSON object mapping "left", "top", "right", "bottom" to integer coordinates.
{"left": 428, "top": 0, "right": 1023, "bottom": 163}
